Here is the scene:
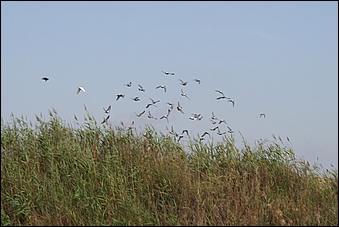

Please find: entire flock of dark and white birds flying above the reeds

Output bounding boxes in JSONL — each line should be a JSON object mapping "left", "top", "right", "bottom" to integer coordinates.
{"left": 42, "top": 71, "right": 268, "bottom": 141}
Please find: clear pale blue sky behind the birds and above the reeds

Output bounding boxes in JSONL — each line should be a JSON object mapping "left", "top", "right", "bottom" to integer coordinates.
{"left": 1, "top": 1, "right": 338, "bottom": 169}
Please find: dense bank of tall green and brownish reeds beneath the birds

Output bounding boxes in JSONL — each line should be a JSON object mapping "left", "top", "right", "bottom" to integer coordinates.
{"left": 1, "top": 110, "right": 338, "bottom": 226}
